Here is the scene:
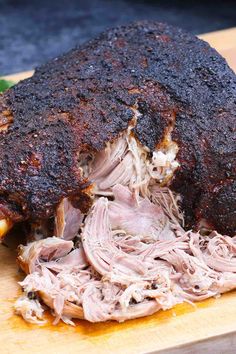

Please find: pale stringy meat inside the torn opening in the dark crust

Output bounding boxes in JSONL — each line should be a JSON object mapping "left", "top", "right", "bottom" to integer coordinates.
{"left": 88, "top": 132, "right": 151, "bottom": 195}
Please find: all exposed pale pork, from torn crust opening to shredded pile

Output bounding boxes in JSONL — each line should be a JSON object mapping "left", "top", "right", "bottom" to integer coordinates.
{"left": 15, "top": 129, "right": 236, "bottom": 325}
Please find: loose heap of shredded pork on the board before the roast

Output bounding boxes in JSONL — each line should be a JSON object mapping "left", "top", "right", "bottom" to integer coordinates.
{"left": 15, "top": 185, "right": 236, "bottom": 324}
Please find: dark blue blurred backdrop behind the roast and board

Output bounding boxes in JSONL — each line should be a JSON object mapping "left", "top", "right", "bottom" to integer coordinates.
{"left": 0, "top": 0, "right": 236, "bottom": 75}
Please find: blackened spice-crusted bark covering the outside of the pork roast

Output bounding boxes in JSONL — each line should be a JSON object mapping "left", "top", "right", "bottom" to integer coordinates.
{"left": 0, "top": 22, "right": 236, "bottom": 235}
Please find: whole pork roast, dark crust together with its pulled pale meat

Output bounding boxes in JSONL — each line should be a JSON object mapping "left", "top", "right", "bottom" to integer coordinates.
{"left": 0, "top": 21, "right": 233, "bottom": 324}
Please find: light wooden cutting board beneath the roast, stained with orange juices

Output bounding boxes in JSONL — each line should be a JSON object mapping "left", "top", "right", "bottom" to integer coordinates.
{"left": 0, "top": 28, "right": 236, "bottom": 354}
